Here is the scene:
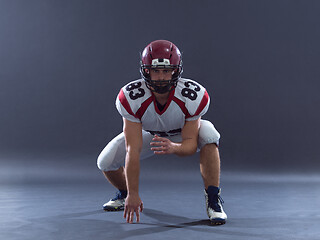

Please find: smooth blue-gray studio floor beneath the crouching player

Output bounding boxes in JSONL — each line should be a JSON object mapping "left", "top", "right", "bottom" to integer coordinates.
{"left": 0, "top": 155, "right": 320, "bottom": 240}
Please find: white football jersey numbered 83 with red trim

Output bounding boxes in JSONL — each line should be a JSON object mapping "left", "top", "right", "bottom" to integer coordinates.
{"left": 116, "top": 78, "right": 210, "bottom": 137}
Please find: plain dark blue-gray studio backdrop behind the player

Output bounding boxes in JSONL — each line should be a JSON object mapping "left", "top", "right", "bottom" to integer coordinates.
{"left": 0, "top": 0, "right": 320, "bottom": 171}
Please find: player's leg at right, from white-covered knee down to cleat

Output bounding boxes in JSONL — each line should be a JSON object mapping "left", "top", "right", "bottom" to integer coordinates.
{"left": 198, "top": 120, "right": 227, "bottom": 224}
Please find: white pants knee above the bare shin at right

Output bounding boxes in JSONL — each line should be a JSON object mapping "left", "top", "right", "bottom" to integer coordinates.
{"left": 198, "top": 119, "right": 220, "bottom": 149}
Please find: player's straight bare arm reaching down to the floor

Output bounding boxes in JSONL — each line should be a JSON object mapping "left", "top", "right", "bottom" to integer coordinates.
{"left": 123, "top": 118, "right": 143, "bottom": 223}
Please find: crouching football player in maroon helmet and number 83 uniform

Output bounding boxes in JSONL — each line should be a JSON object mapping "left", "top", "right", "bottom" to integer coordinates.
{"left": 97, "top": 40, "right": 227, "bottom": 224}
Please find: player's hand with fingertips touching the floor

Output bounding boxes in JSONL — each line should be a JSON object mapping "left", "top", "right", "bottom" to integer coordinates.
{"left": 123, "top": 194, "right": 143, "bottom": 223}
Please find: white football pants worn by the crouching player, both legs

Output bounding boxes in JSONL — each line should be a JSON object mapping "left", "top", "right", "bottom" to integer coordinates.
{"left": 97, "top": 119, "right": 220, "bottom": 171}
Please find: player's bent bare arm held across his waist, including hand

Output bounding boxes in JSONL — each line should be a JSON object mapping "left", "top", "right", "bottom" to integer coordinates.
{"left": 150, "top": 118, "right": 200, "bottom": 156}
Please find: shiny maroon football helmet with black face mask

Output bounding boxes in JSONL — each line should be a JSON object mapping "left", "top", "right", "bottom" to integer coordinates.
{"left": 140, "top": 40, "right": 183, "bottom": 93}
